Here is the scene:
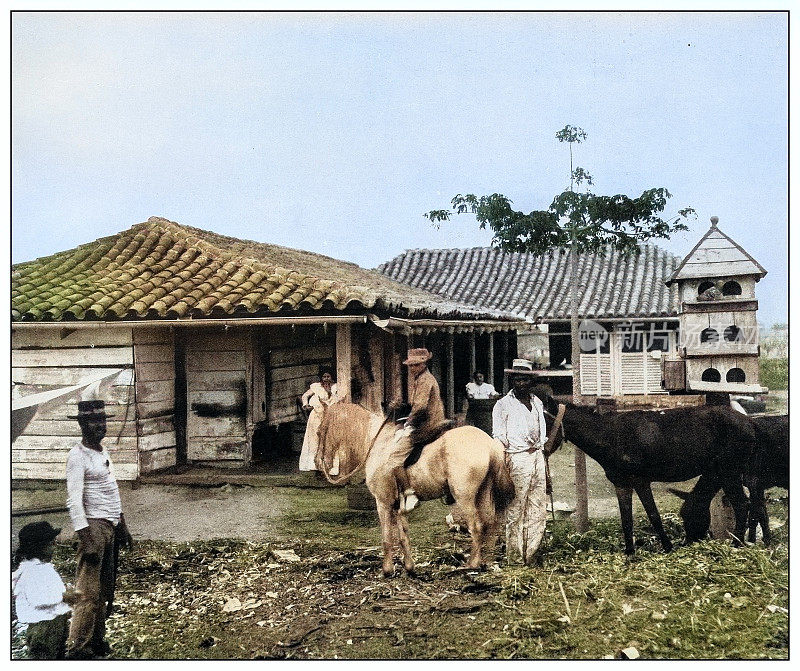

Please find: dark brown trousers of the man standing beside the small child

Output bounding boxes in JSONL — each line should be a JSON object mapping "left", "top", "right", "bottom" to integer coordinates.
{"left": 67, "top": 519, "right": 117, "bottom": 657}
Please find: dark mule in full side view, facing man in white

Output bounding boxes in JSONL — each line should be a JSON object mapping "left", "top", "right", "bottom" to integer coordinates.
{"left": 546, "top": 397, "right": 756, "bottom": 555}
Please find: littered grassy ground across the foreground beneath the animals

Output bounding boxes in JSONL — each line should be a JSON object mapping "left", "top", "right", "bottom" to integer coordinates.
{"left": 13, "top": 488, "right": 789, "bottom": 659}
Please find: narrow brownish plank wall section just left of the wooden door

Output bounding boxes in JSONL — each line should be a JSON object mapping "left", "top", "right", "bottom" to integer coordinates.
{"left": 133, "top": 327, "right": 177, "bottom": 473}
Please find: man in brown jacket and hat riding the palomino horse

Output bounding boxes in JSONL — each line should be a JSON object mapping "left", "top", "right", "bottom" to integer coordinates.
{"left": 394, "top": 347, "right": 445, "bottom": 512}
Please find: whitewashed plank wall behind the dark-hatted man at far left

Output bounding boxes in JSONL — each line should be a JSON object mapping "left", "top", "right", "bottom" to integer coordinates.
{"left": 11, "top": 328, "right": 139, "bottom": 480}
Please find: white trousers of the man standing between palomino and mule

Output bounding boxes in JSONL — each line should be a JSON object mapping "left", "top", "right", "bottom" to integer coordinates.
{"left": 506, "top": 450, "right": 547, "bottom": 564}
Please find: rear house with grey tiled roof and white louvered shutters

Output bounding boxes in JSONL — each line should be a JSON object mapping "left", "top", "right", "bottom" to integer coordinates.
{"left": 378, "top": 244, "right": 680, "bottom": 398}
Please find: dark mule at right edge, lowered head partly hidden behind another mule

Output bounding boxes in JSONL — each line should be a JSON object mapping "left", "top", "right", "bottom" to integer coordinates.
{"left": 669, "top": 415, "right": 789, "bottom": 545}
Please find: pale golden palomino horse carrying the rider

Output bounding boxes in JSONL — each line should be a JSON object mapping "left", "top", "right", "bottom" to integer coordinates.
{"left": 316, "top": 403, "right": 514, "bottom": 576}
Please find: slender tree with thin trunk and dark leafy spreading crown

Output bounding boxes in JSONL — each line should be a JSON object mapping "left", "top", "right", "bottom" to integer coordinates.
{"left": 425, "top": 125, "right": 695, "bottom": 531}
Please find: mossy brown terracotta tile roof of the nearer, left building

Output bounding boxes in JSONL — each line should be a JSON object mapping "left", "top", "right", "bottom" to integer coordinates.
{"left": 11, "top": 217, "right": 524, "bottom": 321}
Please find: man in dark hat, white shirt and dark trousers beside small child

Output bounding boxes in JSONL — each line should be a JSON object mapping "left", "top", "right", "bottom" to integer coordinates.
{"left": 66, "top": 401, "right": 133, "bottom": 659}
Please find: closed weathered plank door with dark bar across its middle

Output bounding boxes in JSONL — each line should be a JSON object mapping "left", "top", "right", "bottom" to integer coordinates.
{"left": 186, "top": 328, "right": 251, "bottom": 467}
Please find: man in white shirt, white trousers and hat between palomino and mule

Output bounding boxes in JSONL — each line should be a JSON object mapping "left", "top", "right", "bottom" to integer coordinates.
{"left": 492, "top": 359, "right": 547, "bottom": 564}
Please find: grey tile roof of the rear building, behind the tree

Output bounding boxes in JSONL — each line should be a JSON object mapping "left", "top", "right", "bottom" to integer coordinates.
{"left": 378, "top": 245, "right": 680, "bottom": 321}
